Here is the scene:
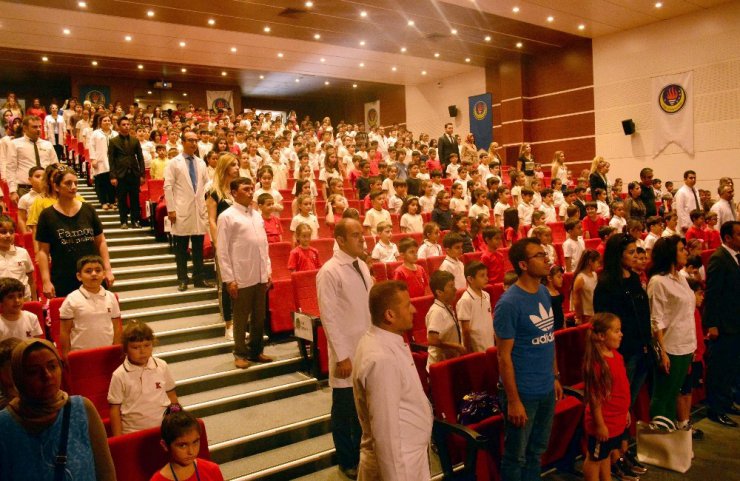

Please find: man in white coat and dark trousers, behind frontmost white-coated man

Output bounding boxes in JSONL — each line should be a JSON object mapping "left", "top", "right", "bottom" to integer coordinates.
{"left": 316, "top": 219, "right": 373, "bottom": 479}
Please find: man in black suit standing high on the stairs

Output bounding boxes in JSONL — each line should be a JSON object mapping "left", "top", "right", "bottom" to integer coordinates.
{"left": 108, "top": 117, "right": 145, "bottom": 229}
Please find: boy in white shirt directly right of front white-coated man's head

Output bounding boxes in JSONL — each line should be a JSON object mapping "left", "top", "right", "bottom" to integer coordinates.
{"left": 426, "top": 271, "right": 467, "bottom": 371}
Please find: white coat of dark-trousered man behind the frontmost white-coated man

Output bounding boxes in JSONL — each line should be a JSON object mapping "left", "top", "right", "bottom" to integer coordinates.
{"left": 316, "top": 248, "right": 373, "bottom": 388}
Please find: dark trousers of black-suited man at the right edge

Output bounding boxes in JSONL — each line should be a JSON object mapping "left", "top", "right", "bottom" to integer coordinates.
{"left": 704, "top": 333, "right": 740, "bottom": 414}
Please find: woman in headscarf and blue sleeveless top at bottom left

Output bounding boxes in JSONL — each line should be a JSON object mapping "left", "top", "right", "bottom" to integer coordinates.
{"left": 0, "top": 339, "right": 116, "bottom": 481}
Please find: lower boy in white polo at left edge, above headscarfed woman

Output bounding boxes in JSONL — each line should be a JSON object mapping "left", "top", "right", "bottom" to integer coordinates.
{"left": 0, "top": 277, "right": 44, "bottom": 341}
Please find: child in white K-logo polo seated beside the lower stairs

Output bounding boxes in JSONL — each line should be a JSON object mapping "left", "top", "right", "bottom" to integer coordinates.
{"left": 108, "top": 321, "right": 178, "bottom": 436}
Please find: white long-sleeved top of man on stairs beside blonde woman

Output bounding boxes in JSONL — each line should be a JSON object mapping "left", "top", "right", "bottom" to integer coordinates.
{"left": 216, "top": 203, "right": 272, "bottom": 289}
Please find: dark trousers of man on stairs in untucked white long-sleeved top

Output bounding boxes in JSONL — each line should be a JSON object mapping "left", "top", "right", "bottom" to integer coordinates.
{"left": 233, "top": 283, "right": 267, "bottom": 360}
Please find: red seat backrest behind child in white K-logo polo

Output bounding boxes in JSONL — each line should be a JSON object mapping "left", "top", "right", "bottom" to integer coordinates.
{"left": 67, "top": 344, "right": 124, "bottom": 419}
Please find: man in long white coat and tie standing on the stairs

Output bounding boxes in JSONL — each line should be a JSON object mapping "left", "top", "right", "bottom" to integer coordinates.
{"left": 165, "top": 132, "right": 213, "bottom": 292}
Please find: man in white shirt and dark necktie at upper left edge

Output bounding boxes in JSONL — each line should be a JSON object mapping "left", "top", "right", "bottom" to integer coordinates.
{"left": 6, "top": 115, "right": 59, "bottom": 204}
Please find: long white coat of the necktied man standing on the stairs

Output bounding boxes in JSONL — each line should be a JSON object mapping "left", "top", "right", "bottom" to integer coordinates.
{"left": 164, "top": 154, "right": 208, "bottom": 236}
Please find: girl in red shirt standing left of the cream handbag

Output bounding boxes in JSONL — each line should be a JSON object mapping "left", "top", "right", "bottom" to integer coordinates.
{"left": 583, "top": 312, "right": 630, "bottom": 481}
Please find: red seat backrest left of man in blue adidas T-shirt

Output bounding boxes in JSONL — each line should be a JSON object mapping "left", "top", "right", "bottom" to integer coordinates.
{"left": 429, "top": 352, "right": 489, "bottom": 423}
